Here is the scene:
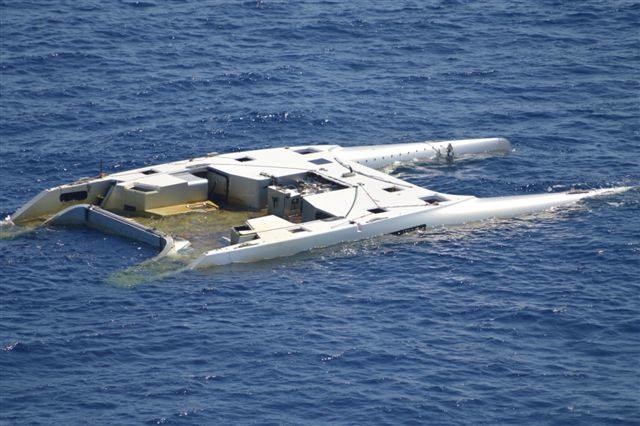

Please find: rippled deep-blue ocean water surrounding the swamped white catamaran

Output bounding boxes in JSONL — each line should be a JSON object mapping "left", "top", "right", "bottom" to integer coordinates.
{"left": 0, "top": 0, "right": 640, "bottom": 425}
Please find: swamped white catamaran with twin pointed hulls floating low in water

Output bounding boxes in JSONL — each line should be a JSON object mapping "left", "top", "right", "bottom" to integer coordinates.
{"left": 5, "top": 138, "right": 628, "bottom": 268}
